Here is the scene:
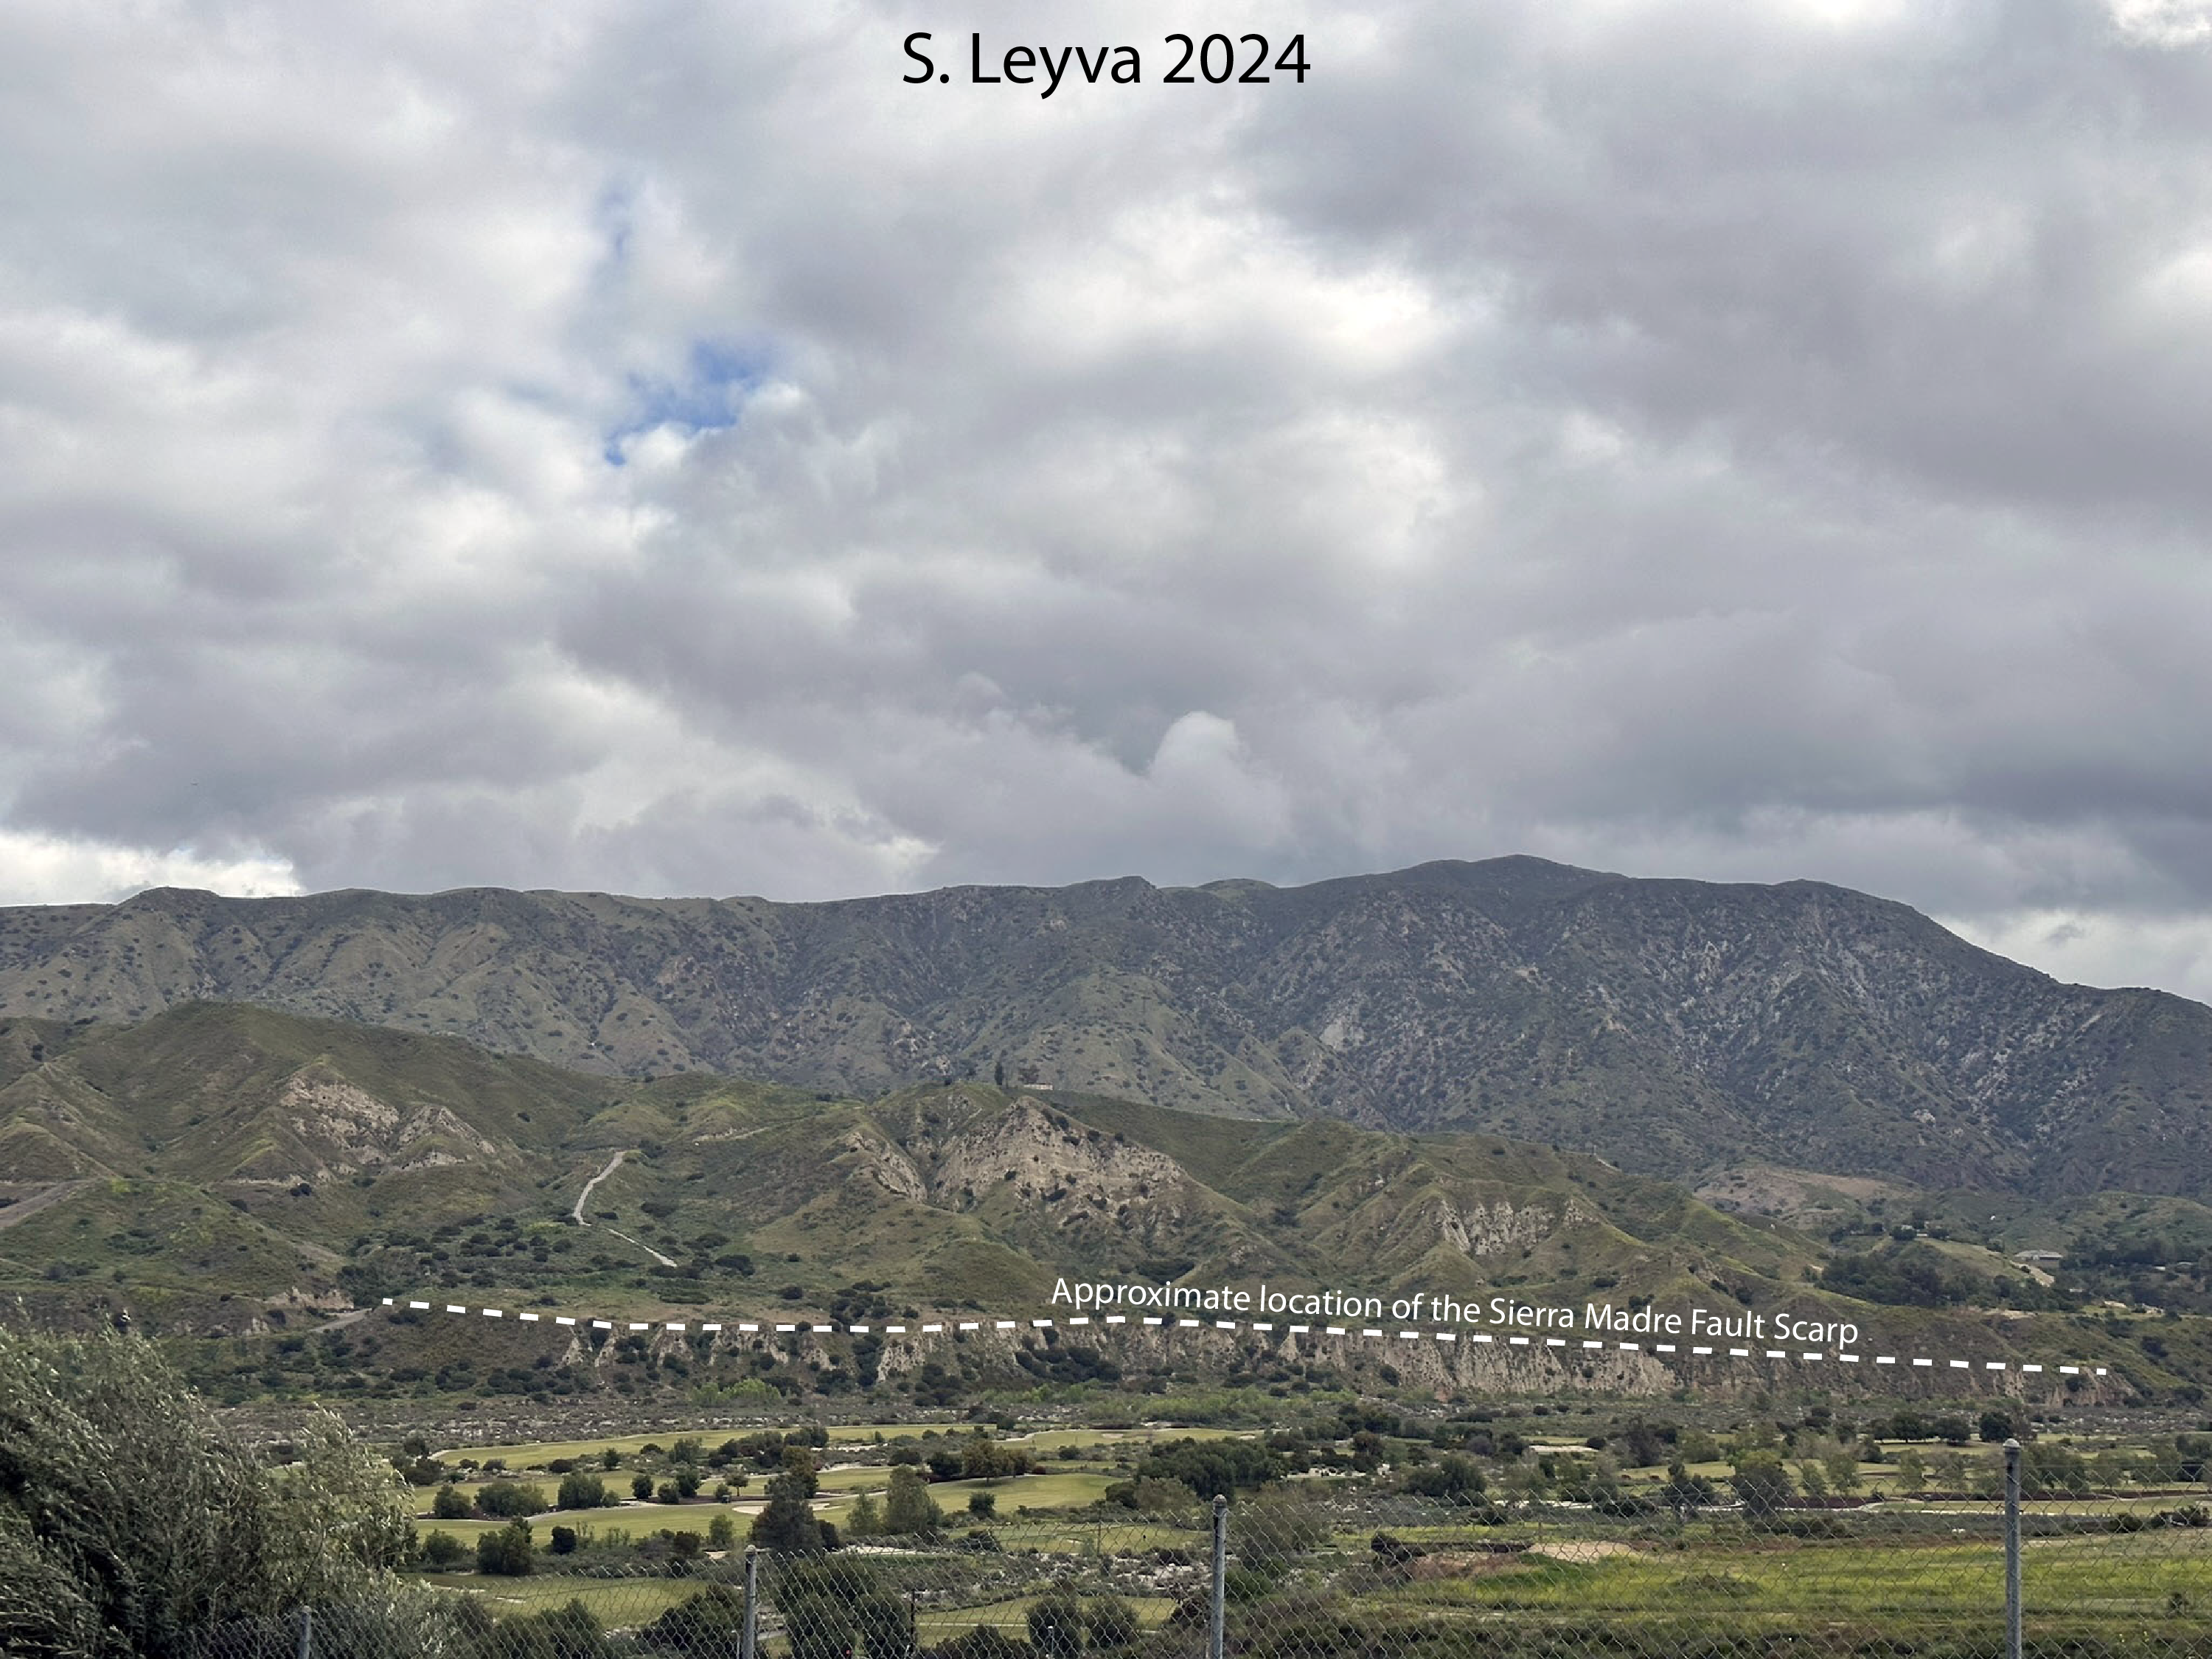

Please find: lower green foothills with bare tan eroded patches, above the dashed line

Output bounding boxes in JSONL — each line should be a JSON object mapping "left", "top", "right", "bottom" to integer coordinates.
{"left": 0, "top": 1004, "right": 1816, "bottom": 1336}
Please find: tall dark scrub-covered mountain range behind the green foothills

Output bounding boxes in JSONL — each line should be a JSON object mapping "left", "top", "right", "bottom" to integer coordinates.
{"left": 0, "top": 858, "right": 2212, "bottom": 1197}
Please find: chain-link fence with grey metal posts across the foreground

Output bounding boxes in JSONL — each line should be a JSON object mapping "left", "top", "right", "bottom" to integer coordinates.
{"left": 184, "top": 1447, "right": 2212, "bottom": 1659}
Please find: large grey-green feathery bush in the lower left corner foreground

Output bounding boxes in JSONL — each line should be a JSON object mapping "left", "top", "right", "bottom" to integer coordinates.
{"left": 0, "top": 1323, "right": 414, "bottom": 1659}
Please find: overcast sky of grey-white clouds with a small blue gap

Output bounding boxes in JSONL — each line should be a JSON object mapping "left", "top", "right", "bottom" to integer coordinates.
{"left": 0, "top": 0, "right": 2212, "bottom": 998}
